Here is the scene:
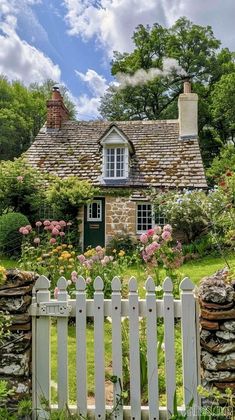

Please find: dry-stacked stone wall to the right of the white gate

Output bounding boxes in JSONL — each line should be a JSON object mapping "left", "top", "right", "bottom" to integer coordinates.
{"left": 198, "top": 270, "right": 235, "bottom": 398}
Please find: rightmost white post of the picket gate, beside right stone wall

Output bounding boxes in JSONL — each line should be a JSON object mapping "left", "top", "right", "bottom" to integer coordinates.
{"left": 180, "top": 277, "right": 198, "bottom": 416}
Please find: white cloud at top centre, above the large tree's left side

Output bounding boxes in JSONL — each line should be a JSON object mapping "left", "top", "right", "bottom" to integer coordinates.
{"left": 64, "top": 0, "right": 182, "bottom": 56}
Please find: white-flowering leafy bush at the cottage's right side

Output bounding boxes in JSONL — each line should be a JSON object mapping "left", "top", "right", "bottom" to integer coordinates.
{"left": 154, "top": 175, "right": 235, "bottom": 252}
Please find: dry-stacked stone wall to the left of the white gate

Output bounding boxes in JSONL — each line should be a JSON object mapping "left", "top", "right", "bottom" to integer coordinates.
{"left": 0, "top": 270, "right": 37, "bottom": 407}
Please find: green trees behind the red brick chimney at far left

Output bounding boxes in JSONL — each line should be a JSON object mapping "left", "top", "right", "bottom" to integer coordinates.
{"left": 0, "top": 76, "right": 75, "bottom": 160}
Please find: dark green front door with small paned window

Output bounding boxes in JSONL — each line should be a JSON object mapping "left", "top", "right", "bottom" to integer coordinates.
{"left": 84, "top": 198, "right": 105, "bottom": 250}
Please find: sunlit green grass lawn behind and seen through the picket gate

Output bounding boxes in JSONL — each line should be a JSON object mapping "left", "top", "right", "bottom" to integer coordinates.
{"left": 0, "top": 253, "right": 235, "bottom": 405}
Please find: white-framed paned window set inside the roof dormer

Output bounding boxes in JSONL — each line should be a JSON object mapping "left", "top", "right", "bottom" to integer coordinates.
{"left": 104, "top": 147, "right": 128, "bottom": 178}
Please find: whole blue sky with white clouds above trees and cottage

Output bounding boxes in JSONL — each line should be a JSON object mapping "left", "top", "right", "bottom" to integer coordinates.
{"left": 0, "top": 0, "right": 235, "bottom": 120}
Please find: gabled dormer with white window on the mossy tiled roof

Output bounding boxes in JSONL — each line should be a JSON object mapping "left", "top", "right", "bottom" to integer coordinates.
{"left": 101, "top": 125, "right": 133, "bottom": 179}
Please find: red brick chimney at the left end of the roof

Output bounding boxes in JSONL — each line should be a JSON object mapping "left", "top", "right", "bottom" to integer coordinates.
{"left": 47, "top": 86, "right": 69, "bottom": 130}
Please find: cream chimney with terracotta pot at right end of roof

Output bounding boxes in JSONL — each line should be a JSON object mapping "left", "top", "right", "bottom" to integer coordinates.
{"left": 178, "top": 79, "right": 198, "bottom": 139}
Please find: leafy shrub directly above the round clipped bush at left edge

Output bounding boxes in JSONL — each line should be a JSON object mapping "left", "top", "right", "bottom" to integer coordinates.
{"left": 0, "top": 158, "right": 46, "bottom": 219}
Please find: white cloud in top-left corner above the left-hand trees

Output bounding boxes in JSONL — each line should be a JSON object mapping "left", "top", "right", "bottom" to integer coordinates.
{"left": 0, "top": 0, "right": 61, "bottom": 85}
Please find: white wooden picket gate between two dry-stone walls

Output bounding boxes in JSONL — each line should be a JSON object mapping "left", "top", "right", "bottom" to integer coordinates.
{"left": 31, "top": 276, "right": 200, "bottom": 420}
